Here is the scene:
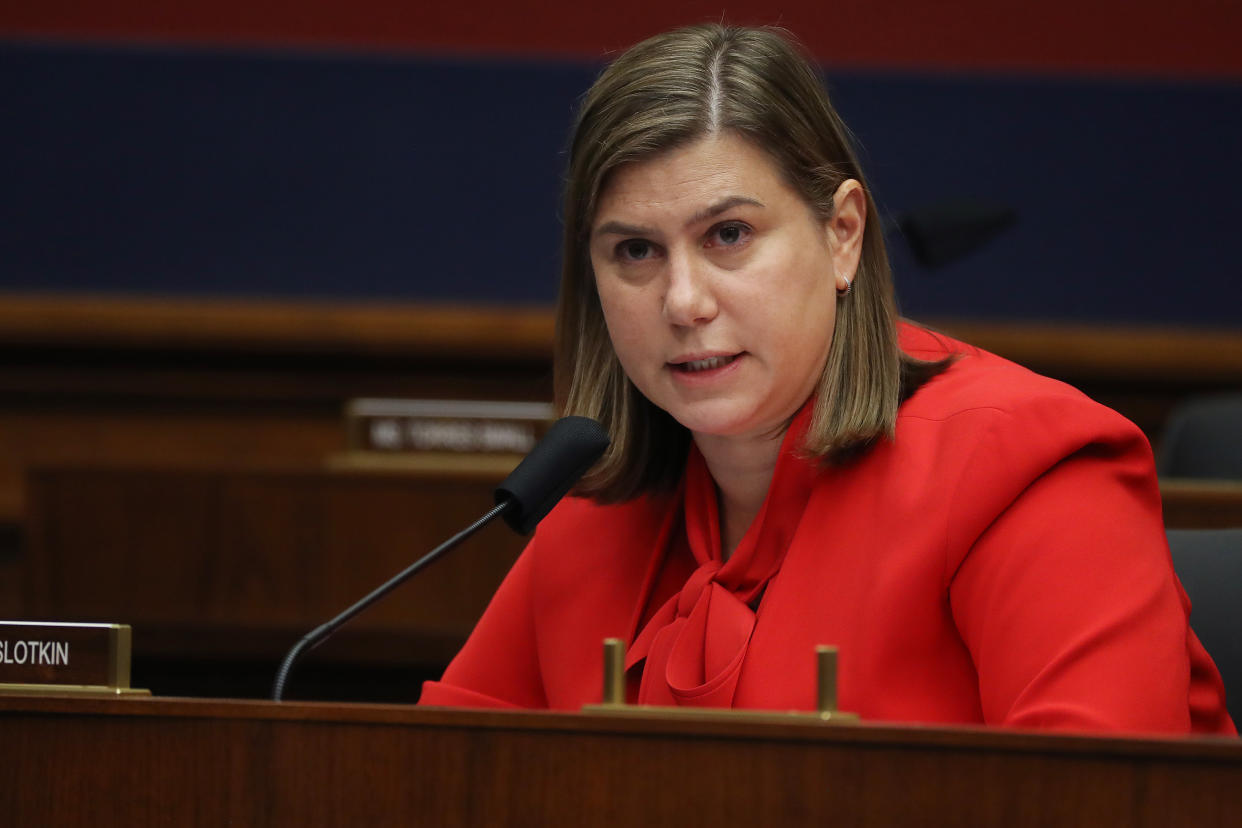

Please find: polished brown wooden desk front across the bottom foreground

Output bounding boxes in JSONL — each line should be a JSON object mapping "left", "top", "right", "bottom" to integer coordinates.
{"left": 0, "top": 698, "right": 1242, "bottom": 828}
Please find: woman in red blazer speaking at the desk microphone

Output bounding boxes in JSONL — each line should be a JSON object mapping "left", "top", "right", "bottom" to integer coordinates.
{"left": 422, "top": 26, "right": 1233, "bottom": 732}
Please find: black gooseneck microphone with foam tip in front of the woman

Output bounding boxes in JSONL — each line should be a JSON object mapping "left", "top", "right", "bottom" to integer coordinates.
{"left": 272, "top": 417, "right": 611, "bottom": 701}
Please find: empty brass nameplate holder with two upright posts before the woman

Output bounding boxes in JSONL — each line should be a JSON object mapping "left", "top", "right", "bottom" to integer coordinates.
{"left": 582, "top": 638, "right": 858, "bottom": 725}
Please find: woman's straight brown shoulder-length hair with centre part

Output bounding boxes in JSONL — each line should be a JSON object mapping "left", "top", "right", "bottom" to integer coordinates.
{"left": 554, "top": 25, "right": 940, "bottom": 502}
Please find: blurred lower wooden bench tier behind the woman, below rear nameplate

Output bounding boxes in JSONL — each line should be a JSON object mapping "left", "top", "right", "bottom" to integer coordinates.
{"left": 7, "top": 466, "right": 1242, "bottom": 701}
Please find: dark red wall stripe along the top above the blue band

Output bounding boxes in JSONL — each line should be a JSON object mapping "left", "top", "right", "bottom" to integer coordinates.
{"left": 7, "top": 0, "right": 1242, "bottom": 78}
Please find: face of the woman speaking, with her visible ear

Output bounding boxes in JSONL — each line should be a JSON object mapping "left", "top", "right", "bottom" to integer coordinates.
{"left": 590, "top": 133, "right": 866, "bottom": 446}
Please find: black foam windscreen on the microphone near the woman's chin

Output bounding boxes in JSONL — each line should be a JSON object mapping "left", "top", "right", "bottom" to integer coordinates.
{"left": 496, "top": 417, "right": 611, "bottom": 535}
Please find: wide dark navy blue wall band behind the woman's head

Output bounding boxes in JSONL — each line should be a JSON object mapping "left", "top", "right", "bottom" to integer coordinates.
{"left": 0, "top": 41, "right": 1242, "bottom": 328}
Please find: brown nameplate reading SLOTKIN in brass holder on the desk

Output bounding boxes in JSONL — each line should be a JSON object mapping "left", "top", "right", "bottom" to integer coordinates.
{"left": 0, "top": 621, "right": 150, "bottom": 696}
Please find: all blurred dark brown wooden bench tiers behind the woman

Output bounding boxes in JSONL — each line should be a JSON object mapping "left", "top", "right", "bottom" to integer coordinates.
{"left": 0, "top": 297, "right": 1242, "bottom": 699}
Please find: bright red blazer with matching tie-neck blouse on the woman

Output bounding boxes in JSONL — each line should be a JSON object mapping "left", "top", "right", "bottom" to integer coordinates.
{"left": 421, "top": 328, "right": 1235, "bottom": 734}
